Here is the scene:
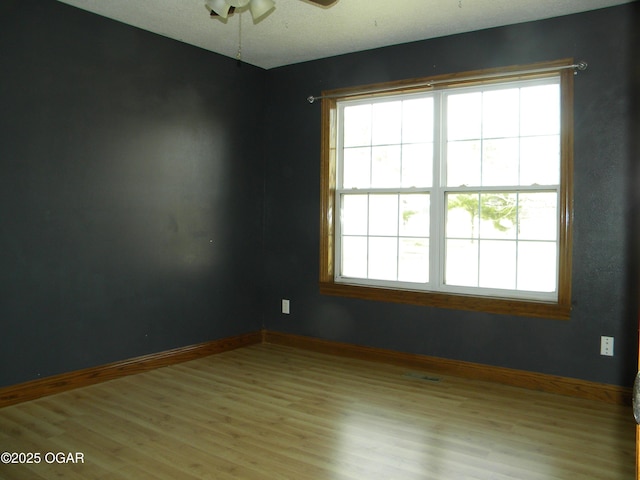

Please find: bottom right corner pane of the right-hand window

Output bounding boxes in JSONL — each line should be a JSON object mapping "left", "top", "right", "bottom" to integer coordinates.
{"left": 518, "top": 242, "right": 557, "bottom": 292}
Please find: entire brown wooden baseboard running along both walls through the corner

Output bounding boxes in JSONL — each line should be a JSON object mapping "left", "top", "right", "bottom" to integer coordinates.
{"left": 0, "top": 330, "right": 631, "bottom": 408}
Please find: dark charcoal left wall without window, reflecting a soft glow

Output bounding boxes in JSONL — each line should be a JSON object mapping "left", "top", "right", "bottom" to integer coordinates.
{"left": 0, "top": 0, "right": 264, "bottom": 386}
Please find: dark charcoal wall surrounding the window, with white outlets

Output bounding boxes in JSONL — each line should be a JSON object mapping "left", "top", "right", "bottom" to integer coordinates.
{"left": 265, "top": 3, "right": 638, "bottom": 385}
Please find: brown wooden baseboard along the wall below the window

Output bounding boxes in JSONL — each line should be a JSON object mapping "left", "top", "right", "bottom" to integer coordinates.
{"left": 262, "top": 331, "right": 631, "bottom": 405}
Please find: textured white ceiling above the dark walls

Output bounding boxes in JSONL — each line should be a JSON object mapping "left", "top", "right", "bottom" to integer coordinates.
{"left": 59, "top": 0, "right": 634, "bottom": 69}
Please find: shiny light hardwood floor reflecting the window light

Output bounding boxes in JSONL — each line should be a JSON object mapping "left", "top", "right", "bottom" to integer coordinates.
{"left": 0, "top": 344, "right": 635, "bottom": 480}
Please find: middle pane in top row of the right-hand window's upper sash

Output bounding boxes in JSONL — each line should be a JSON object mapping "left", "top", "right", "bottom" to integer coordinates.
{"left": 482, "top": 88, "right": 520, "bottom": 138}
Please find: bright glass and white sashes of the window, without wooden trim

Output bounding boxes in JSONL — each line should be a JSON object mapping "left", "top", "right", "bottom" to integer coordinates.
{"left": 332, "top": 71, "right": 565, "bottom": 301}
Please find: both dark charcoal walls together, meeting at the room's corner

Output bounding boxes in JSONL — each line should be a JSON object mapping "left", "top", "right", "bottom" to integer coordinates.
{"left": 0, "top": 0, "right": 640, "bottom": 387}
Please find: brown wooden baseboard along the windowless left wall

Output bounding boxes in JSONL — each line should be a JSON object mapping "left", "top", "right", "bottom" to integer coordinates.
{"left": 0, "top": 332, "right": 262, "bottom": 408}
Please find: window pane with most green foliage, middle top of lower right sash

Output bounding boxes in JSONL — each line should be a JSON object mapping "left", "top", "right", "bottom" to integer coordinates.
{"left": 480, "top": 192, "right": 518, "bottom": 239}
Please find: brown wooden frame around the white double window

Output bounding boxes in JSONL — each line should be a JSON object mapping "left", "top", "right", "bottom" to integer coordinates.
{"left": 319, "top": 59, "right": 574, "bottom": 320}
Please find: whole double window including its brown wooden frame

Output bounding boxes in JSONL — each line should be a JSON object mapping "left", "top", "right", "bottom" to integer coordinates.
{"left": 320, "top": 61, "right": 573, "bottom": 318}
